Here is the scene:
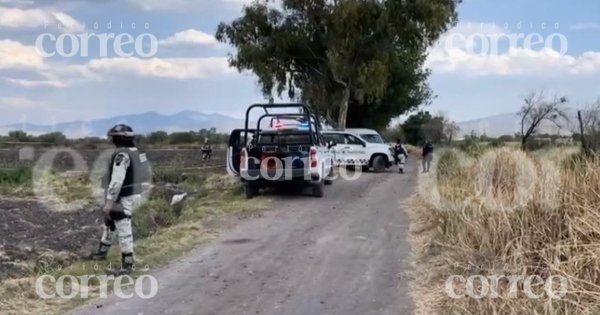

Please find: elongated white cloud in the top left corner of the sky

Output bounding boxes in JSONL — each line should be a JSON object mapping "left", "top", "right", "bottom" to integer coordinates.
{"left": 0, "top": 6, "right": 84, "bottom": 32}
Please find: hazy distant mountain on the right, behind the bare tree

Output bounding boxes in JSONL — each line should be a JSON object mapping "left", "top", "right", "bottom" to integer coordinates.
{"left": 458, "top": 108, "right": 577, "bottom": 137}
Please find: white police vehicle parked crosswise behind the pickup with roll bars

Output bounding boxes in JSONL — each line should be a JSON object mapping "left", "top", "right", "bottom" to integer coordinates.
{"left": 322, "top": 129, "right": 394, "bottom": 172}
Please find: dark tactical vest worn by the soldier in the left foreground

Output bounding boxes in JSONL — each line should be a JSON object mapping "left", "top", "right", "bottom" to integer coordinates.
{"left": 103, "top": 148, "right": 152, "bottom": 197}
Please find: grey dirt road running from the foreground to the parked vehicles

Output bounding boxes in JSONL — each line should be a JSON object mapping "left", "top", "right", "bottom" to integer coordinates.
{"left": 76, "top": 161, "right": 417, "bottom": 315}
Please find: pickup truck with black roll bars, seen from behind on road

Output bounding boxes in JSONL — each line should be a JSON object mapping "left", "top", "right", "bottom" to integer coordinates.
{"left": 227, "top": 104, "right": 333, "bottom": 198}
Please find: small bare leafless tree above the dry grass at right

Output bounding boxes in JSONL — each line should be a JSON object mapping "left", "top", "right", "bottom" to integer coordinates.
{"left": 519, "top": 91, "right": 568, "bottom": 148}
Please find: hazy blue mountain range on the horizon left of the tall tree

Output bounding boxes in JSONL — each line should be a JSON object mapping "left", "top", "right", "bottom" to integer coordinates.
{"left": 0, "top": 110, "right": 244, "bottom": 138}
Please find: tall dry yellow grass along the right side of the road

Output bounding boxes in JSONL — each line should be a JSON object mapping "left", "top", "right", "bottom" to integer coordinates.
{"left": 410, "top": 148, "right": 600, "bottom": 315}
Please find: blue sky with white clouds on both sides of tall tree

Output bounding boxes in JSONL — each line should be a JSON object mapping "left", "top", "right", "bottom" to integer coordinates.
{"left": 0, "top": 0, "right": 600, "bottom": 125}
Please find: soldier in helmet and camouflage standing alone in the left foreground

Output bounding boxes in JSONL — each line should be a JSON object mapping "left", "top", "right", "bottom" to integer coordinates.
{"left": 90, "top": 125, "right": 151, "bottom": 275}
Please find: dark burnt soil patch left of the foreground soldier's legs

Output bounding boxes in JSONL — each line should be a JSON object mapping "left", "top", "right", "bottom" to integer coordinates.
{"left": 0, "top": 200, "right": 102, "bottom": 281}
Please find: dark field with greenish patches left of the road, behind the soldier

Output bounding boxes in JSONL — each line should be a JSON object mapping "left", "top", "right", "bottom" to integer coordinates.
{"left": 0, "top": 149, "right": 232, "bottom": 298}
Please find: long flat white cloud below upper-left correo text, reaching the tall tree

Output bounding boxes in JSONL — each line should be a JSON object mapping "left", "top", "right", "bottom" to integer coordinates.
{"left": 87, "top": 57, "right": 234, "bottom": 79}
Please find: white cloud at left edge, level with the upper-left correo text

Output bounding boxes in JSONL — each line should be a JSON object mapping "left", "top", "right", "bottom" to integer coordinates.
{"left": 0, "top": 39, "right": 44, "bottom": 69}
